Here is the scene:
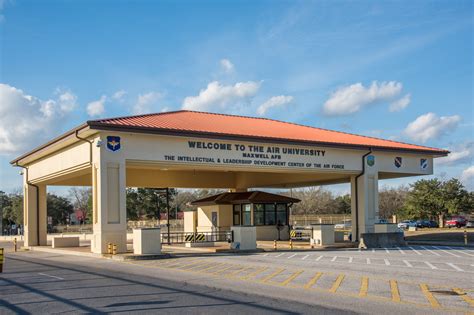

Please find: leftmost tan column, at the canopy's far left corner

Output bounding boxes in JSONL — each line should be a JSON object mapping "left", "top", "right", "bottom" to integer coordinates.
{"left": 23, "top": 184, "right": 47, "bottom": 246}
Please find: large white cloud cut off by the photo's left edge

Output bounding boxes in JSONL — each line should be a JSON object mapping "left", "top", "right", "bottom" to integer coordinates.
{"left": 0, "top": 83, "right": 73, "bottom": 155}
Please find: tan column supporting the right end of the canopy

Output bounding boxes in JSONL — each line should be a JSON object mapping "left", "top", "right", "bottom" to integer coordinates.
{"left": 351, "top": 162, "right": 379, "bottom": 241}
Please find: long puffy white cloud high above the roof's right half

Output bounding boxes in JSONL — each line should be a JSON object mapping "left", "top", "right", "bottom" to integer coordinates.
{"left": 323, "top": 81, "right": 403, "bottom": 116}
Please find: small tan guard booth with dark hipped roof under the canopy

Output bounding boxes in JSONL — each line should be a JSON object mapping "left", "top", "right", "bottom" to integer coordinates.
{"left": 184, "top": 191, "right": 300, "bottom": 241}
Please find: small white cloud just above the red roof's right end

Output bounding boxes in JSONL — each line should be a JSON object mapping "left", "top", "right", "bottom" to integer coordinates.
{"left": 404, "top": 113, "right": 461, "bottom": 143}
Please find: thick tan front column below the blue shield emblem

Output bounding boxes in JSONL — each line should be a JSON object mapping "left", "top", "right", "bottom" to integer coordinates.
{"left": 92, "top": 159, "right": 127, "bottom": 253}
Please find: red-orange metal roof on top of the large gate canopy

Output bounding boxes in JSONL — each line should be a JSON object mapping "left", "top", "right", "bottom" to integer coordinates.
{"left": 87, "top": 110, "right": 449, "bottom": 155}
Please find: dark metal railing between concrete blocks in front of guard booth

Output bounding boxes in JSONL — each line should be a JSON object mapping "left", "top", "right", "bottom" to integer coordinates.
{"left": 161, "top": 231, "right": 234, "bottom": 244}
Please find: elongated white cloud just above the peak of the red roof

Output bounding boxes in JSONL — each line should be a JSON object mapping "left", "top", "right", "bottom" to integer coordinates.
{"left": 183, "top": 81, "right": 261, "bottom": 111}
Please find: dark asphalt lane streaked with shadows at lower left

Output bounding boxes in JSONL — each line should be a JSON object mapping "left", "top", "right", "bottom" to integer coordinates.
{"left": 0, "top": 252, "right": 351, "bottom": 314}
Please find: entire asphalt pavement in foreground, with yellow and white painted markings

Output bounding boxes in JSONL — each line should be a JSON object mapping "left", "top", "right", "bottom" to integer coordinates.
{"left": 0, "top": 246, "right": 474, "bottom": 314}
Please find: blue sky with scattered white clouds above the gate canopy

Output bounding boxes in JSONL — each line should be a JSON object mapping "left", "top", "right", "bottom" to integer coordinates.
{"left": 0, "top": 0, "right": 474, "bottom": 195}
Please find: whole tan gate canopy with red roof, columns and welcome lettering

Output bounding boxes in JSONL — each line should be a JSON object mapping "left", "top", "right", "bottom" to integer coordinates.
{"left": 11, "top": 111, "right": 449, "bottom": 253}
